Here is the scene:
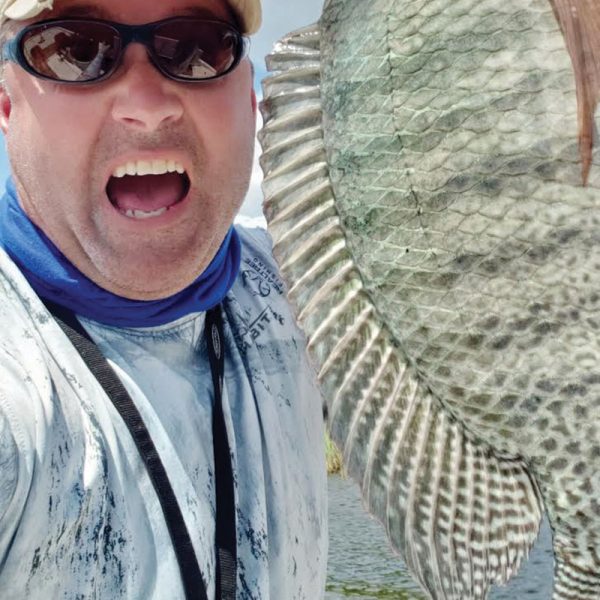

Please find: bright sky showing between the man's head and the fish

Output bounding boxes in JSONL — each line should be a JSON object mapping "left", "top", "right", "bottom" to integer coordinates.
{"left": 0, "top": 0, "right": 323, "bottom": 222}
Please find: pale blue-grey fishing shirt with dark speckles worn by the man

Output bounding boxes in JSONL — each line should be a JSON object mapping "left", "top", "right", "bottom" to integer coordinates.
{"left": 0, "top": 228, "right": 327, "bottom": 600}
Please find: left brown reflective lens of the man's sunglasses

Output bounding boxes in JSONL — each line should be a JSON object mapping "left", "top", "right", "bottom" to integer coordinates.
{"left": 21, "top": 21, "right": 120, "bottom": 82}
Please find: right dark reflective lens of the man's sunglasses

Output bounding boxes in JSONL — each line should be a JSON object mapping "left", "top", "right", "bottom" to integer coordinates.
{"left": 152, "top": 19, "right": 243, "bottom": 81}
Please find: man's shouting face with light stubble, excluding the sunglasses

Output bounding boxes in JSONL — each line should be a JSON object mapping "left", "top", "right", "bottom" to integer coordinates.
{"left": 0, "top": 0, "right": 256, "bottom": 299}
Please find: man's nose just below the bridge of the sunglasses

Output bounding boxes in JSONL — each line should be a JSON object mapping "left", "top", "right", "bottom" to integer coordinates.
{"left": 111, "top": 44, "right": 183, "bottom": 132}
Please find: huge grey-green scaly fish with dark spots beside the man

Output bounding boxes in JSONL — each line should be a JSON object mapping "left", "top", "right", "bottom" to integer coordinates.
{"left": 261, "top": 0, "right": 600, "bottom": 600}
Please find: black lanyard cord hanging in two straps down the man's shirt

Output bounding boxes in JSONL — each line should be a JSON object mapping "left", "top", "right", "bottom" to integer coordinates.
{"left": 44, "top": 300, "right": 237, "bottom": 600}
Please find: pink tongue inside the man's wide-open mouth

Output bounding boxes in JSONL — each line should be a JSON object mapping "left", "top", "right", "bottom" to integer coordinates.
{"left": 106, "top": 173, "right": 184, "bottom": 212}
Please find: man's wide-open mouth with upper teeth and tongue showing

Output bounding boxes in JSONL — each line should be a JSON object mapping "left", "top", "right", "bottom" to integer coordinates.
{"left": 106, "top": 160, "right": 190, "bottom": 219}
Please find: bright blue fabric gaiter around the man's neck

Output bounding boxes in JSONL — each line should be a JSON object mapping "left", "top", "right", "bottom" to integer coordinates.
{"left": 0, "top": 179, "right": 241, "bottom": 327}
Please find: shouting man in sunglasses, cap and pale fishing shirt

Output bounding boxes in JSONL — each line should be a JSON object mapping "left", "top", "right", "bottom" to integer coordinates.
{"left": 0, "top": 0, "right": 327, "bottom": 599}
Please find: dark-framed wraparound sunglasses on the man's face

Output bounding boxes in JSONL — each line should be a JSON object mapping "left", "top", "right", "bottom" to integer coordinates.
{"left": 2, "top": 17, "right": 249, "bottom": 84}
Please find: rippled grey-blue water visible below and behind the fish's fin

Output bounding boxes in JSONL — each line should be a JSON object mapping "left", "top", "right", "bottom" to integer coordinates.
{"left": 325, "top": 476, "right": 553, "bottom": 600}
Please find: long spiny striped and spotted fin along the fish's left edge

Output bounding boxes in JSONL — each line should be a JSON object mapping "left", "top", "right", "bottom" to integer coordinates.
{"left": 260, "top": 25, "right": 542, "bottom": 600}
